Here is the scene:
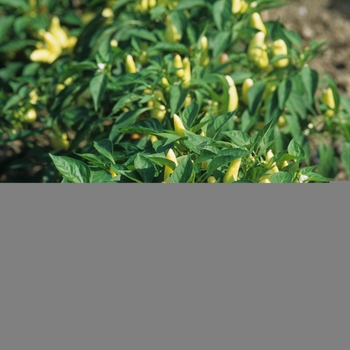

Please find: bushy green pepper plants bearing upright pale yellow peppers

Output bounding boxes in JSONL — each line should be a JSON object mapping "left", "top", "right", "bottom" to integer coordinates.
{"left": 0, "top": 0, "right": 350, "bottom": 183}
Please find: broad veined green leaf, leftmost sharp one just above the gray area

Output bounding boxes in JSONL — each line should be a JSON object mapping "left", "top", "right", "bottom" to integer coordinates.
{"left": 49, "top": 153, "right": 91, "bottom": 183}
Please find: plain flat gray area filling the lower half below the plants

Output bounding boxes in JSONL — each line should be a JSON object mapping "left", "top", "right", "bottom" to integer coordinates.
{"left": 0, "top": 183, "right": 350, "bottom": 350}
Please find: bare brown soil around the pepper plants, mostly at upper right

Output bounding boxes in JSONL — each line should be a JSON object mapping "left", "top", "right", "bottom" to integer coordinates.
{"left": 0, "top": 0, "right": 350, "bottom": 182}
